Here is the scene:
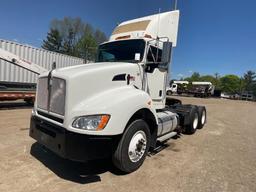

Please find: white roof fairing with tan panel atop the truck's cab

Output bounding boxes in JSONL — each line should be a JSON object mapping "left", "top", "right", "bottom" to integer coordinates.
{"left": 109, "top": 10, "right": 180, "bottom": 47}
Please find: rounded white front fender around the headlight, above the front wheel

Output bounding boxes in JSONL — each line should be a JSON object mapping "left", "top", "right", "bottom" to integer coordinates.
{"left": 65, "top": 86, "right": 157, "bottom": 135}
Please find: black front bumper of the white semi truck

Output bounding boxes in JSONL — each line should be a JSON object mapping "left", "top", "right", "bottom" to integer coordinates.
{"left": 29, "top": 116, "right": 118, "bottom": 162}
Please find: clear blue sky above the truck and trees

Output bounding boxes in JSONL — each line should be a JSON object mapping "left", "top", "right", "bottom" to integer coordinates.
{"left": 0, "top": 0, "right": 256, "bottom": 79}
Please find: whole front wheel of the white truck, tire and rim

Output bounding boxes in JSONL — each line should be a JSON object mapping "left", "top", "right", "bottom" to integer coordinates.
{"left": 112, "top": 119, "right": 150, "bottom": 173}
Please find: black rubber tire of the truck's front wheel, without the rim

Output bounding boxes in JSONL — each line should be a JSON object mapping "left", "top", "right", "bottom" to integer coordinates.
{"left": 112, "top": 119, "right": 150, "bottom": 173}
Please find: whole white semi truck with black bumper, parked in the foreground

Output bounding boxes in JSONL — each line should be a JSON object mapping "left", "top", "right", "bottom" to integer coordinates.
{"left": 30, "top": 10, "right": 206, "bottom": 173}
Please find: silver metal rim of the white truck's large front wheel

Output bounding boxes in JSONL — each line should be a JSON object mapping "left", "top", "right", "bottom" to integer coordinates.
{"left": 128, "top": 131, "right": 147, "bottom": 162}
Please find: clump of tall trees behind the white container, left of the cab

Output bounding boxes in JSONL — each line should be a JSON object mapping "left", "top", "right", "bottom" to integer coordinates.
{"left": 42, "top": 17, "right": 106, "bottom": 60}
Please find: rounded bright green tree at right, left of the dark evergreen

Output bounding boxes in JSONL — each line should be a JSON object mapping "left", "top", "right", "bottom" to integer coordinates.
{"left": 220, "top": 75, "right": 241, "bottom": 94}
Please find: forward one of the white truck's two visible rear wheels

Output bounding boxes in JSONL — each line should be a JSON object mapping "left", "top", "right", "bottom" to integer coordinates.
{"left": 185, "top": 106, "right": 199, "bottom": 134}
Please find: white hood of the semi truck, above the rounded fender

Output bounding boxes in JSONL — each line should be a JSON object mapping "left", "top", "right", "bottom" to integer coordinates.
{"left": 39, "top": 62, "right": 142, "bottom": 115}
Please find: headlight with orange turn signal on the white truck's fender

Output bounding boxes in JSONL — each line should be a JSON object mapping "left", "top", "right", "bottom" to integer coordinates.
{"left": 72, "top": 115, "right": 110, "bottom": 131}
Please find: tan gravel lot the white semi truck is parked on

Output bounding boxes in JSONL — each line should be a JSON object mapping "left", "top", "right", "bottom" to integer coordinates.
{"left": 0, "top": 97, "right": 256, "bottom": 192}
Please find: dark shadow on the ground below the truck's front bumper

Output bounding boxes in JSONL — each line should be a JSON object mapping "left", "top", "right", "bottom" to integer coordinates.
{"left": 30, "top": 142, "right": 113, "bottom": 184}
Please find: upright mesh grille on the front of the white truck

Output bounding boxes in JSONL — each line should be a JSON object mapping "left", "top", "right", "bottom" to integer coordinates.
{"left": 37, "top": 77, "right": 66, "bottom": 115}
